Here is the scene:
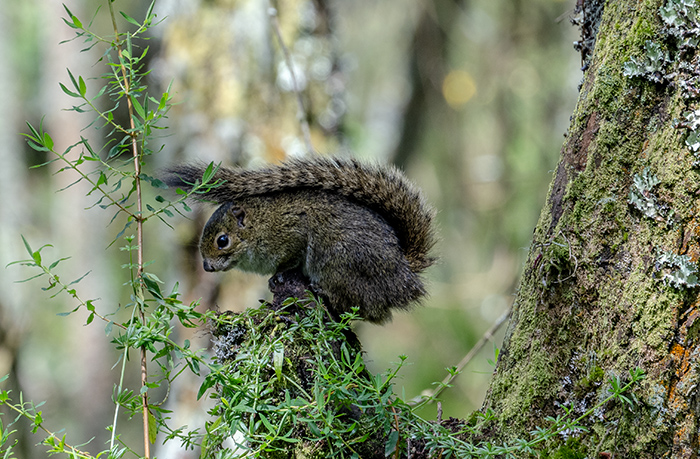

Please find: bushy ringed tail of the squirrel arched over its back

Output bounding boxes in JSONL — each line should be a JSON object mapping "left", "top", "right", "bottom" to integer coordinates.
{"left": 164, "top": 157, "right": 435, "bottom": 273}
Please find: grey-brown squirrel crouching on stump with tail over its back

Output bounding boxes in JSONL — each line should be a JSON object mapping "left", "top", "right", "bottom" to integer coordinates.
{"left": 164, "top": 156, "right": 435, "bottom": 324}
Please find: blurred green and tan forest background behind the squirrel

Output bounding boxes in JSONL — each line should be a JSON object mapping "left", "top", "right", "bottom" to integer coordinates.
{"left": 0, "top": 0, "right": 581, "bottom": 458}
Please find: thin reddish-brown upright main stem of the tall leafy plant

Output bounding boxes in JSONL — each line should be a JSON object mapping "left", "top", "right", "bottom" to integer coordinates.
{"left": 107, "top": 0, "right": 151, "bottom": 459}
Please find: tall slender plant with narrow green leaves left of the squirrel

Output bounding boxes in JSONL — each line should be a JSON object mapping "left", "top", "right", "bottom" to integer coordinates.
{"left": 0, "top": 1, "right": 217, "bottom": 458}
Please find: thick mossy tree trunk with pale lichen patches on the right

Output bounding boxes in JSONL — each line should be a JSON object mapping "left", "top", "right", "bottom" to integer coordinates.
{"left": 484, "top": 0, "right": 700, "bottom": 458}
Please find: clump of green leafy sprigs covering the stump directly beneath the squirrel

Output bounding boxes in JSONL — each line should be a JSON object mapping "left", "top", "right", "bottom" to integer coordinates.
{"left": 202, "top": 300, "right": 396, "bottom": 457}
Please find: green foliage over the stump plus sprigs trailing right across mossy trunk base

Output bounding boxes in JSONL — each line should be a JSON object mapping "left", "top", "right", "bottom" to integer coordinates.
{"left": 196, "top": 300, "right": 644, "bottom": 458}
